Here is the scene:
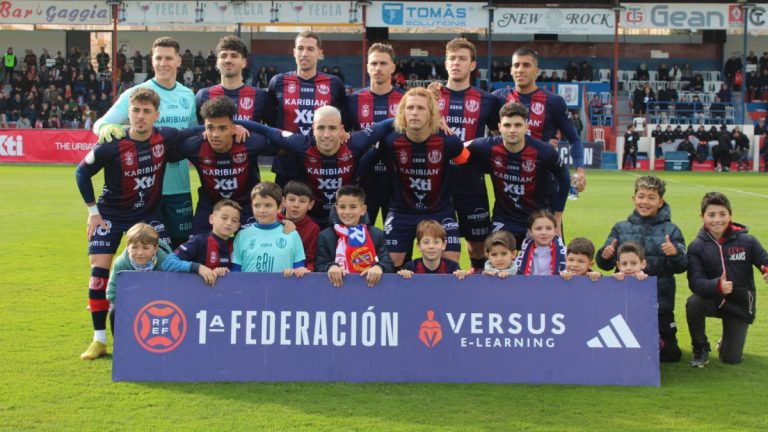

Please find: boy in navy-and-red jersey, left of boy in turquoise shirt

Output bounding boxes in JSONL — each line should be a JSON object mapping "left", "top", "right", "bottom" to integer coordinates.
{"left": 174, "top": 199, "right": 242, "bottom": 276}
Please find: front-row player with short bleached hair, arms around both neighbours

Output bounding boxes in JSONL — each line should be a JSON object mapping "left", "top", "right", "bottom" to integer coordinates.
{"left": 245, "top": 105, "right": 392, "bottom": 229}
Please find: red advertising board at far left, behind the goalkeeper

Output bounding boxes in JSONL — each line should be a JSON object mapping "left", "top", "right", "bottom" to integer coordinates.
{"left": 0, "top": 129, "right": 97, "bottom": 163}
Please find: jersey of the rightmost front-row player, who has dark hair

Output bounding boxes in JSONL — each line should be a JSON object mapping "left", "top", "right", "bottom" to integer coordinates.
{"left": 467, "top": 136, "right": 570, "bottom": 227}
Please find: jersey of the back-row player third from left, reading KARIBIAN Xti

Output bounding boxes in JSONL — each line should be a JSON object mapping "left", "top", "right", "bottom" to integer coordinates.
{"left": 267, "top": 72, "right": 346, "bottom": 179}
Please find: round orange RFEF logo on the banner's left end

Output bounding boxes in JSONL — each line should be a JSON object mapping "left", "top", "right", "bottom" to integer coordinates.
{"left": 133, "top": 300, "right": 187, "bottom": 354}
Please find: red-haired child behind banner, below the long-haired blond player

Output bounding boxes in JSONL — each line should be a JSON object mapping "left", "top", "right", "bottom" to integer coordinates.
{"left": 397, "top": 220, "right": 468, "bottom": 280}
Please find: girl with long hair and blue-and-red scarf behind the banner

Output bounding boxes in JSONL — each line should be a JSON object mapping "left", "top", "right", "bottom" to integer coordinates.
{"left": 517, "top": 210, "right": 566, "bottom": 276}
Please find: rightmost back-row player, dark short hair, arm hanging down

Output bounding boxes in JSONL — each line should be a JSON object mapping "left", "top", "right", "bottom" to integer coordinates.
{"left": 493, "top": 48, "right": 587, "bottom": 193}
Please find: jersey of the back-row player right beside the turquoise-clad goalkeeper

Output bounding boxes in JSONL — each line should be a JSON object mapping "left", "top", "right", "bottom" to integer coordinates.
{"left": 195, "top": 84, "right": 271, "bottom": 124}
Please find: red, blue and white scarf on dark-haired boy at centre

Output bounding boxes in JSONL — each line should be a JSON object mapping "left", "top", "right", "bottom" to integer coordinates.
{"left": 333, "top": 224, "right": 379, "bottom": 273}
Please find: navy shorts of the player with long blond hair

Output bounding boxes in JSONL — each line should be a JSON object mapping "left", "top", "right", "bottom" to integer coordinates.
{"left": 384, "top": 208, "right": 461, "bottom": 253}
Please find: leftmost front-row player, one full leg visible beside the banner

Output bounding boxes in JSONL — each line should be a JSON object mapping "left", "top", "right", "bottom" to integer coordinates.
{"left": 76, "top": 88, "right": 195, "bottom": 360}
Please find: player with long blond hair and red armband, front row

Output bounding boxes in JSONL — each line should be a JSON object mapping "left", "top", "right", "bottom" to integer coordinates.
{"left": 379, "top": 88, "right": 468, "bottom": 268}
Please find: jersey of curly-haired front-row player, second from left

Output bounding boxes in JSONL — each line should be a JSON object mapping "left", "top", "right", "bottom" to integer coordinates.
{"left": 178, "top": 133, "right": 278, "bottom": 209}
